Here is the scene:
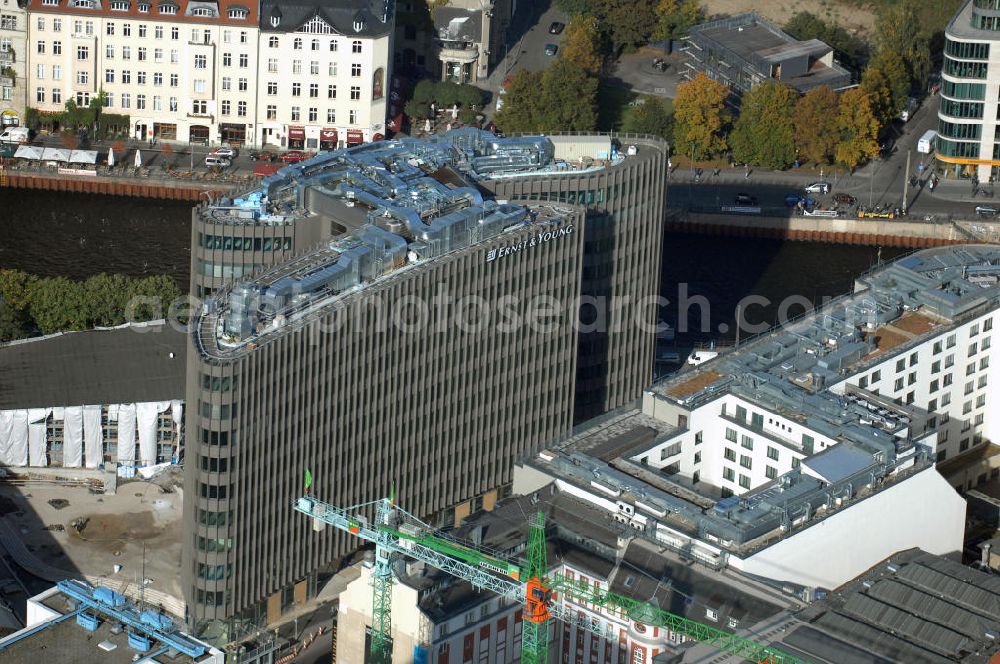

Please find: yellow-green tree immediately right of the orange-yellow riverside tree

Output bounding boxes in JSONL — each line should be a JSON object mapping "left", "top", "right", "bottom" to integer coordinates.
{"left": 729, "top": 80, "right": 799, "bottom": 168}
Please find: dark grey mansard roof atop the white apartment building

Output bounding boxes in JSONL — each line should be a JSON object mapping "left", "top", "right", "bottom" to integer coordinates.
{"left": 260, "top": 0, "right": 395, "bottom": 37}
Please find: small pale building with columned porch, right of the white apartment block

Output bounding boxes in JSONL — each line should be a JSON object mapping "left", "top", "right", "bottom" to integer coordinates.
{"left": 433, "top": 0, "right": 513, "bottom": 84}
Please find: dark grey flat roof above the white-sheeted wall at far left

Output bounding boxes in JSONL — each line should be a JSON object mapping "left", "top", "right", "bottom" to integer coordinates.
{"left": 0, "top": 325, "right": 187, "bottom": 410}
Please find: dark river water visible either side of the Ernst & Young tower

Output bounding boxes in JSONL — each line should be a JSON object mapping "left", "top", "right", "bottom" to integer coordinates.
{"left": 0, "top": 188, "right": 902, "bottom": 340}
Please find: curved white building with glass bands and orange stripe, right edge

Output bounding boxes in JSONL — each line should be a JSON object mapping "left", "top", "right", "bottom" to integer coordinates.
{"left": 934, "top": 0, "right": 1000, "bottom": 182}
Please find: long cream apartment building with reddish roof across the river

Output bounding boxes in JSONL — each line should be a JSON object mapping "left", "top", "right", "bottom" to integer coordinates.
{"left": 28, "top": 0, "right": 257, "bottom": 144}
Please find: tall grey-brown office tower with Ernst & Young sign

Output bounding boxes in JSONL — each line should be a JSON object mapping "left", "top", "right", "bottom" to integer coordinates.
{"left": 183, "top": 130, "right": 666, "bottom": 637}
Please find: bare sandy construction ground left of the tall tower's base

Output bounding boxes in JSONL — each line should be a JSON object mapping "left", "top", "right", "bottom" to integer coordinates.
{"left": 0, "top": 474, "right": 182, "bottom": 596}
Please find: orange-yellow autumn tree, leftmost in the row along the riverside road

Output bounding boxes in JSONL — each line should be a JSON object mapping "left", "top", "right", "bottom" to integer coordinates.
{"left": 674, "top": 72, "right": 729, "bottom": 159}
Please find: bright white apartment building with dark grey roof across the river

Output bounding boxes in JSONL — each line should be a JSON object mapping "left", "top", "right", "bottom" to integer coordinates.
{"left": 256, "top": 0, "right": 395, "bottom": 150}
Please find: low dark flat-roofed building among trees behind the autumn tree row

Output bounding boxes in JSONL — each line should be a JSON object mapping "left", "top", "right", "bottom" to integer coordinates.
{"left": 682, "top": 12, "right": 851, "bottom": 101}
